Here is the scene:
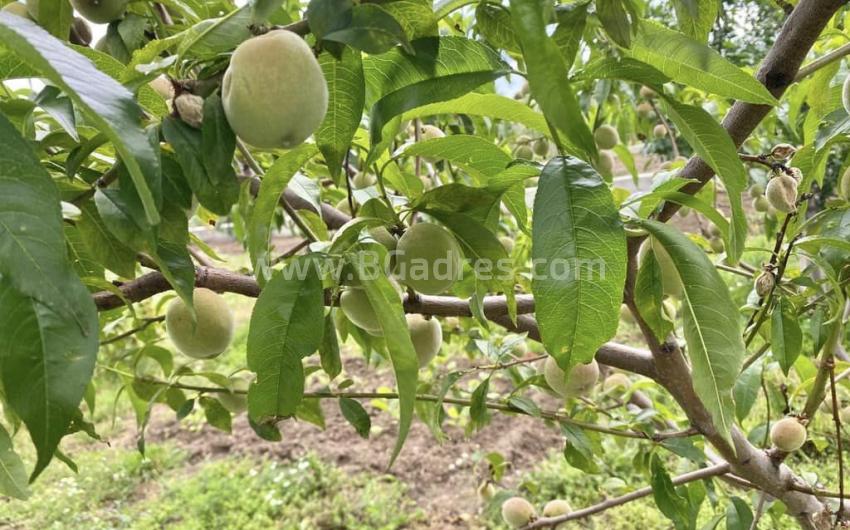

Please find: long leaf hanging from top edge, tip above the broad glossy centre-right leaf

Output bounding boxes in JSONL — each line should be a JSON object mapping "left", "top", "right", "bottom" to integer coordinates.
{"left": 511, "top": 0, "right": 596, "bottom": 160}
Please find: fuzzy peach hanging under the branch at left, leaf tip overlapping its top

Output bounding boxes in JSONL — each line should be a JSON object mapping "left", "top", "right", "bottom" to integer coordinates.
{"left": 165, "top": 287, "right": 233, "bottom": 359}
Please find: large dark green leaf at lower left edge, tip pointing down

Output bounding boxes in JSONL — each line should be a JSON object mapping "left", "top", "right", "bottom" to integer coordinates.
{"left": 0, "top": 271, "right": 98, "bottom": 479}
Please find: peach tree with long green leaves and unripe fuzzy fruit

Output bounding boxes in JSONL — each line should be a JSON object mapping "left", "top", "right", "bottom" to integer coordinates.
{"left": 0, "top": 0, "right": 850, "bottom": 529}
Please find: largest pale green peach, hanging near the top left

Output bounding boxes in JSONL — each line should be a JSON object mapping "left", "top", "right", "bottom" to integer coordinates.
{"left": 221, "top": 30, "right": 328, "bottom": 149}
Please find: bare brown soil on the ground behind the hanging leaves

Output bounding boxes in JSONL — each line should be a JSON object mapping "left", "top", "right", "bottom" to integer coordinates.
{"left": 122, "top": 352, "right": 563, "bottom": 529}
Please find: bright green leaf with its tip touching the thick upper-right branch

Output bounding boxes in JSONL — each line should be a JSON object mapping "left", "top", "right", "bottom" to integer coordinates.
{"left": 629, "top": 20, "right": 777, "bottom": 105}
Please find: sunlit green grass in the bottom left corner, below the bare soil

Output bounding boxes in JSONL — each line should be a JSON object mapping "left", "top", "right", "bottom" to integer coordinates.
{"left": 0, "top": 445, "right": 424, "bottom": 530}
